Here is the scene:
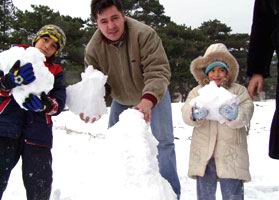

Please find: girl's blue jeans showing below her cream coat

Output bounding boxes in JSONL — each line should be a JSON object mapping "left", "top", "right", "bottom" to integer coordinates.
{"left": 197, "top": 159, "right": 244, "bottom": 200}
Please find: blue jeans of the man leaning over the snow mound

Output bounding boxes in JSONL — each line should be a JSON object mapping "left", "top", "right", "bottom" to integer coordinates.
{"left": 109, "top": 91, "right": 183, "bottom": 199}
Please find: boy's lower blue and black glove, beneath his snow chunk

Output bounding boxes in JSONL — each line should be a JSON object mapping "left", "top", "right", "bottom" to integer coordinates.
{"left": 23, "top": 92, "right": 52, "bottom": 112}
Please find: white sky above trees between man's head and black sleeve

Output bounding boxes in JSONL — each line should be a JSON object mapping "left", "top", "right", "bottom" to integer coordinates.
{"left": 160, "top": 0, "right": 254, "bottom": 33}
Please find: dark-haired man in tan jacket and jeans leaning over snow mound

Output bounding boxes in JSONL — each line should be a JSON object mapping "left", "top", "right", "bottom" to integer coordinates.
{"left": 81, "top": 0, "right": 180, "bottom": 198}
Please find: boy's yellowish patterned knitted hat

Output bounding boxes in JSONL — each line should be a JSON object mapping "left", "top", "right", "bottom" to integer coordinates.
{"left": 32, "top": 24, "right": 66, "bottom": 55}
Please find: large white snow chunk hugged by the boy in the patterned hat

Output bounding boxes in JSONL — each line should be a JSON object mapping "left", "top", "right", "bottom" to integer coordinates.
{"left": 0, "top": 47, "right": 54, "bottom": 109}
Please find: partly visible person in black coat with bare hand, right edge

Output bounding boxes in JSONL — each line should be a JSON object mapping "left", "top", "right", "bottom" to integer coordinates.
{"left": 247, "top": 0, "right": 279, "bottom": 159}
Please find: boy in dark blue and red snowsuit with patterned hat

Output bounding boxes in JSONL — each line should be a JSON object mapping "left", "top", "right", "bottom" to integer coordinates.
{"left": 0, "top": 24, "right": 66, "bottom": 200}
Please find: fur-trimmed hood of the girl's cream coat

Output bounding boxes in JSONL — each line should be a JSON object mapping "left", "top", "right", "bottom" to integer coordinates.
{"left": 190, "top": 43, "right": 239, "bottom": 88}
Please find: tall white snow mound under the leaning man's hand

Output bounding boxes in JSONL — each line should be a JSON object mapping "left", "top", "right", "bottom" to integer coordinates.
{"left": 92, "top": 109, "right": 176, "bottom": 200}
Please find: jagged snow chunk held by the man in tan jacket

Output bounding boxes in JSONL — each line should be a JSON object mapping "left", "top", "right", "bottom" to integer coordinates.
{"left": 66, "top": 65, "right": 107, "bottom": 118}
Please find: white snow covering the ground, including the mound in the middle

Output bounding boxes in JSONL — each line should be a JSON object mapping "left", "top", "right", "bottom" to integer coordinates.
{"left": 2, "top": 100, "right": 279, "bottom": 200}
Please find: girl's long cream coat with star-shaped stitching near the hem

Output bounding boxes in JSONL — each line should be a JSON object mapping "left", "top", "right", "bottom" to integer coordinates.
{"left": 182, "top": 43, "right": 254, "bottom": 181}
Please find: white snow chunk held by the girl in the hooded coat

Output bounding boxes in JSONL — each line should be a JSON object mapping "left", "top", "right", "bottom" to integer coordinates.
{"left": 190, "top": 81, "right": 238, "bottom": 123}
